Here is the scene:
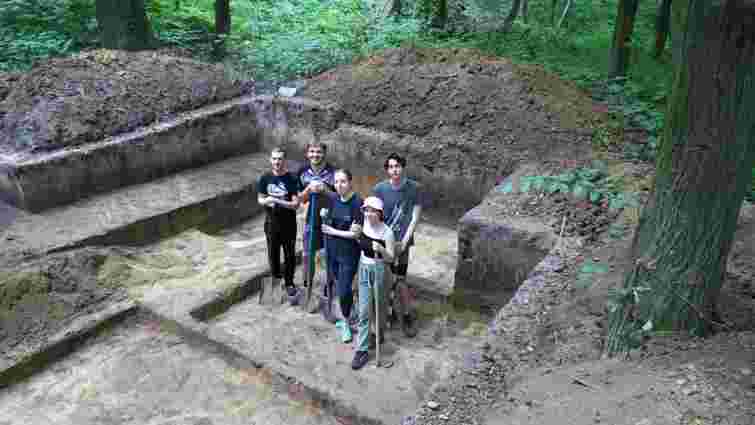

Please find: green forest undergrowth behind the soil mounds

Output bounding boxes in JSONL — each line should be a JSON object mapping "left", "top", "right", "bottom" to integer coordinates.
{"left": 0, "top": 0, "right": 755, "bottom": 199}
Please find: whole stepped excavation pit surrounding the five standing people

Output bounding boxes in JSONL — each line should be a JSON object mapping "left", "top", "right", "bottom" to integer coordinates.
{"left": 0, "top": 88, "right": 554, "bottom": 424}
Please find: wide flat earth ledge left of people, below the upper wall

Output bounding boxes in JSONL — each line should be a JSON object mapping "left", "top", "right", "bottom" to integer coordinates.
{"left": 4, "top": 153, "right": 270, "bottom": 258}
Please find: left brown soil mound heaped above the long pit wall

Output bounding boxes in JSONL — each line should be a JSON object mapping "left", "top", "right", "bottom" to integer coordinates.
{"left": 0, "top": 50, "right": 252, "bottom": 152}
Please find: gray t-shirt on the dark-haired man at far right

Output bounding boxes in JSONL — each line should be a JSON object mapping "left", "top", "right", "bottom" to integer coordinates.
{"left": 372, "top": 179, "right": 425, "bottom": 246}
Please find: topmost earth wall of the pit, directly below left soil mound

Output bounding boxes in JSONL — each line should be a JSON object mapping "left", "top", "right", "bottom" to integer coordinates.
{"left": 0, "top": 96, "right": 342, "bottom": 212}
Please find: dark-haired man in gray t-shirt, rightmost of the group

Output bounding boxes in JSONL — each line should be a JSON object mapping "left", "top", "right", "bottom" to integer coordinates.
{"left": 372, "top": 153, "right": 425, "bottom": 337}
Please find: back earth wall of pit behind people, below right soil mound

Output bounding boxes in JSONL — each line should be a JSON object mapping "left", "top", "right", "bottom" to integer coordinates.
{"left": 258, "top": 103, "right": 516, "bottom": 218}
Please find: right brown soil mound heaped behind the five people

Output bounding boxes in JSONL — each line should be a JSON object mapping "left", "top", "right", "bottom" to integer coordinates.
{"left": 303, "top": 47, "right": 595, "bottom": 169}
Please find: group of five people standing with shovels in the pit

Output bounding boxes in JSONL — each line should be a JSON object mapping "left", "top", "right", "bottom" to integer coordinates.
{"left": 257, "top": 142, "right": 423, "bottom": 370}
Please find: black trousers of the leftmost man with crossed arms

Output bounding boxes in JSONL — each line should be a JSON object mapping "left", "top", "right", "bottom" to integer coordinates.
{"left": 265, "top": 219, "right": 296, "bottom": 285}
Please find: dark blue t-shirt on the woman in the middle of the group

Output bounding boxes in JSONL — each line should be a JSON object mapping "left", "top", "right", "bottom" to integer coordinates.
{"left": 325, "top": 193, "right": 364, "bottom": 259}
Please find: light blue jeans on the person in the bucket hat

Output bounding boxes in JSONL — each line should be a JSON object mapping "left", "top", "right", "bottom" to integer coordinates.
{"left": 356, "top": 262, "right": 388, "bottom": 351}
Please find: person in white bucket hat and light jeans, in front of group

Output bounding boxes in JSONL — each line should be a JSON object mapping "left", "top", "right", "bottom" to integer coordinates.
{"left": 351, "top": 196, "right": 394, "bottom": 370}
